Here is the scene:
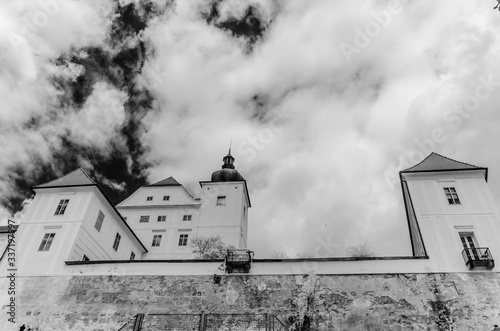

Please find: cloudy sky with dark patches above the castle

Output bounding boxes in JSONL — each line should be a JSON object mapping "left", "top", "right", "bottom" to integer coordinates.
{"left": 0, "top": 0, "right": 500, "bottom": 258}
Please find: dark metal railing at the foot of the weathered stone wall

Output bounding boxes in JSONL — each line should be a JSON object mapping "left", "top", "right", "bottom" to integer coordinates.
{"left": 119, "top": 314, "right": 289, "bottom": 331}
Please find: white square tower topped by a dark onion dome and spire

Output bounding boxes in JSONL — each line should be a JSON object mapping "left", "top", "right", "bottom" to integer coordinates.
{"left": 198, "top": 149, "right": 251, "bottom": 248}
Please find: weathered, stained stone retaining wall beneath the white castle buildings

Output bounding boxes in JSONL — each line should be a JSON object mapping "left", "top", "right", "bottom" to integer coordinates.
{"left": 0, "top": 272, "right": 500, "bottom": 331}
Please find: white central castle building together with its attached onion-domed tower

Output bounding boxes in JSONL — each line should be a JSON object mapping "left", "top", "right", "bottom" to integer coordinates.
{"left": 116, "top": 154, "right": 250, "bottom": 260}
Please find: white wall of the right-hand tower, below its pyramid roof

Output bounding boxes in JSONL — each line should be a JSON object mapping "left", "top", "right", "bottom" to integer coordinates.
{"left": 405, "top": 171, "right": 500, "bottom": 272}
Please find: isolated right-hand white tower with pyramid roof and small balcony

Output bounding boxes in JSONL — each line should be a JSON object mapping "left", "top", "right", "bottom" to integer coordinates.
{"left": 400, "top": 153, "right": 500, "bottom": 272}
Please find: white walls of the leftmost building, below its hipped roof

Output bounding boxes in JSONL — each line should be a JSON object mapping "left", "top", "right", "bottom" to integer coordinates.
{"left": 16, "top": 169, "right": 146, "bottom": 274}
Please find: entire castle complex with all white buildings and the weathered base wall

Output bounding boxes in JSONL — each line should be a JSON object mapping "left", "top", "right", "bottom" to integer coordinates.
{"left": 0, "top": 153, "right": 500, "bottom": 331}
